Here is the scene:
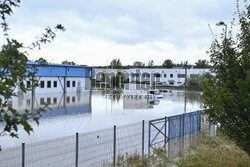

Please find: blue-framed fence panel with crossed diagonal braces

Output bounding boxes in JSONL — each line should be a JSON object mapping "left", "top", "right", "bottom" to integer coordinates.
{"left": 148, "top": 117, "right": 168, "bottom": 149}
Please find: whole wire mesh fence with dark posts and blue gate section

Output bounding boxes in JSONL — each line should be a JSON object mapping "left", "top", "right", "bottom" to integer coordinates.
{"left": 0, "top": 111, "right": 208, "bottom": 167}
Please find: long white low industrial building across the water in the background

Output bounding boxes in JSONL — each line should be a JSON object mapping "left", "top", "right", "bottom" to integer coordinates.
{"left": 92, "top": 68, "right": 211, "bottom": 86}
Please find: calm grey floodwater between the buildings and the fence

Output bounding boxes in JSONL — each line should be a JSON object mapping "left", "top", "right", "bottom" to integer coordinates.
{"left": 0, "top": 90, "right": 203, "bottom": 148}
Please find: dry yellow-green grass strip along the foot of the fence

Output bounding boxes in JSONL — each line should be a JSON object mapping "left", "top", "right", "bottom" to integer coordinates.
{"left": 112, "top": 132, "right": 250, "bottom": 167}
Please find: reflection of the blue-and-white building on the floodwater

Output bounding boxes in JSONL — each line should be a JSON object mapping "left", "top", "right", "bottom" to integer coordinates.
{"left": 11, "top": 91, "right": 91, "bottom": 116}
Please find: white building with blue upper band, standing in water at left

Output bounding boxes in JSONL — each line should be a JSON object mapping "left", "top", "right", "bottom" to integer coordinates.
{"left": 15, "top": 61, "right": 92, "bottom": 93}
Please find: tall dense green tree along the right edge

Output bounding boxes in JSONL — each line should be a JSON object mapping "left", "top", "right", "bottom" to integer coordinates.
{"left": 203, "top": 1, "right": 250, "bottom": 154}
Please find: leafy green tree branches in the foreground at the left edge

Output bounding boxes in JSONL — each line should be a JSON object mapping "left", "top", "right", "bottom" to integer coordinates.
{"left": 0, "top": 0, "right": 64, "bottom": 140}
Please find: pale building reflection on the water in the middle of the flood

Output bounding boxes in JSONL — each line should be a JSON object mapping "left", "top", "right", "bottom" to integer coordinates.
{"left": 123, "top": 96, "right": 160, "bottom": 109}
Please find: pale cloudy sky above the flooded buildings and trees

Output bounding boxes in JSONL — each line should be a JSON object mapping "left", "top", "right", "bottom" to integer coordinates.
{"left": 0, "top": 0, "right": 246, "bottom": 66}
